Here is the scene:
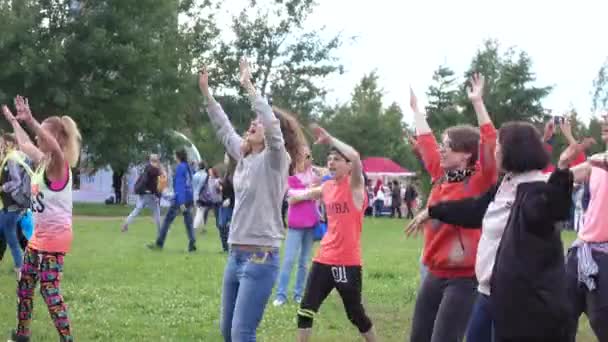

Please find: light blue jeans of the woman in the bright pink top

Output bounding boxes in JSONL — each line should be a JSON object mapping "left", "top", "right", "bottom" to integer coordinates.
{"left": 277, "top": 228, "right": 314, "bottom": 301}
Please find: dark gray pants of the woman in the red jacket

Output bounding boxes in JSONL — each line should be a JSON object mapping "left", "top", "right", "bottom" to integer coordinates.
{"left": 410, "top": 272, "right": 477, "bottom": 342}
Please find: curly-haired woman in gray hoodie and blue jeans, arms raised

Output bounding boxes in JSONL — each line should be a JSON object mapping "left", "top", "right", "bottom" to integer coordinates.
{"left": 199, "top": 58, "right": 306, "bottom": 342}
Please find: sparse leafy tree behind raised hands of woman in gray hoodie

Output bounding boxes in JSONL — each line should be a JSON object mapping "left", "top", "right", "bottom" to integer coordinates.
{"left": 209, "top": 0, "right": 342, "bottom": 121}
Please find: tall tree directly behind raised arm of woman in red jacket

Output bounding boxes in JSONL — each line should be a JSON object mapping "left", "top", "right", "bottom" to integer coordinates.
{"left": 458, "top": 40, "right": 552, "bottom": 127}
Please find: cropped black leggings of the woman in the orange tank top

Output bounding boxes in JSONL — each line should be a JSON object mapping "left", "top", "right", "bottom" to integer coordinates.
{"left": 298, "top": 262, "right": 372, "bottom": 334}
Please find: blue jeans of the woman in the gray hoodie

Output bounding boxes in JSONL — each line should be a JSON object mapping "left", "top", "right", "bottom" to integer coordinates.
{"left": 220, "top": 248, "right": 279, "bottom": 342}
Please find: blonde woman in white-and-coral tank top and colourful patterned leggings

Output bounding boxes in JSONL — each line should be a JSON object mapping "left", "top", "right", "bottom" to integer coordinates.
{"left": 2, "top": 96, "right": 80, "bottom": 341}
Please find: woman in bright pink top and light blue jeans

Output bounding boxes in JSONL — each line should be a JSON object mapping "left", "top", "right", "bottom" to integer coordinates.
{"left": 273, "top": 146, "right": 321, "bottom": 306}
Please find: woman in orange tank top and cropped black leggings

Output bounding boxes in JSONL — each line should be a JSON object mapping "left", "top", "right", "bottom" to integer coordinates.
{"left": 288, "top": 125, "right": 376, "bottom": 342}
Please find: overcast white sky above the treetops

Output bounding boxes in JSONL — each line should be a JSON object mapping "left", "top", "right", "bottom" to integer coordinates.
{"left": 216, "top": 0, "right": 608, "bottom": 121}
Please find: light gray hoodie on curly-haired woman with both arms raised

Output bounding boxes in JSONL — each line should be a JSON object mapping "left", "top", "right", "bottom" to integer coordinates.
{"left": 207, "top": 96, "right": 290, "bottom": 247}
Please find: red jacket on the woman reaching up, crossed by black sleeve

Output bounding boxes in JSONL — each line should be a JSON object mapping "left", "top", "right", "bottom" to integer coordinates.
{"left": 418, "top": 123, "right": 498, "bottom": 278}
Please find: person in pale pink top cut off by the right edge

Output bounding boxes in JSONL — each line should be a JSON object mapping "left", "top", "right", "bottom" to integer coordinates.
{"left": 566, "top": 116, "right": 608, "bottom": 342}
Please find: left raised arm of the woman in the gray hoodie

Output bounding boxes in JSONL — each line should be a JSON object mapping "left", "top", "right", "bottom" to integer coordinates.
{"left": 198, "top": 68, "right": 243, "bottom": 160}
